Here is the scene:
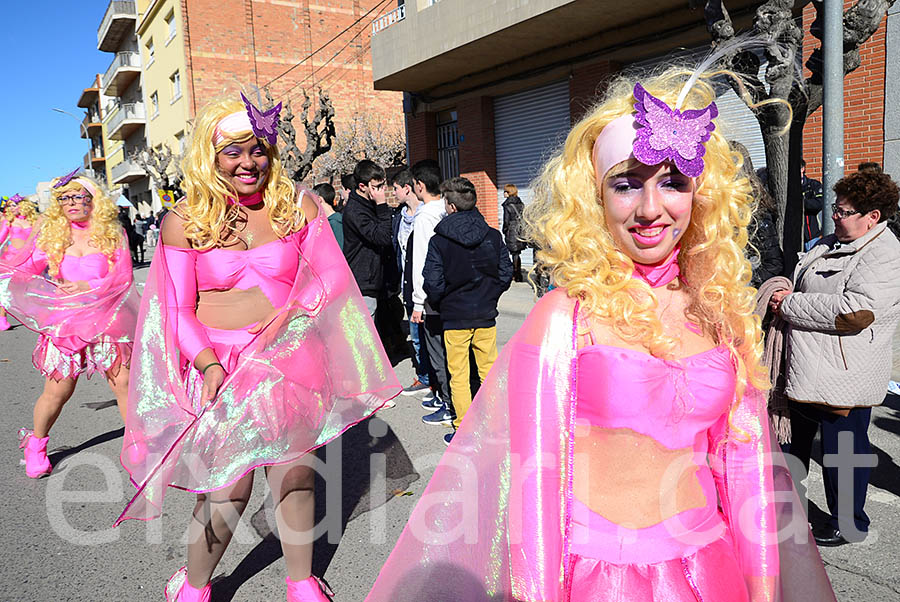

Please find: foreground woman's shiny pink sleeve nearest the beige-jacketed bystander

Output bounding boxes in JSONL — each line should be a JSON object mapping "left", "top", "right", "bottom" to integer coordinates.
{"left": 709, "top": 387, "right": 780, "bottom": 600}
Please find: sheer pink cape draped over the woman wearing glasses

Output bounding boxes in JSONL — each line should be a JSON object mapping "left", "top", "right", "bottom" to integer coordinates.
{"left": 0, "top": 220, "right": 140, "bottom": 354}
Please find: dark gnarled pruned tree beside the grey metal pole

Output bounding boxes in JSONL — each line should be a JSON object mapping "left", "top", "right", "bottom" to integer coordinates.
{"left": 690, "top": 0, "right": 895, "bottom": 267}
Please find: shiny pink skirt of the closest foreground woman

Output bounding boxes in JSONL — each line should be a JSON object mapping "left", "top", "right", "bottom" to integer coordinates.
{"left": 570, "top": 500, "right": 750, "bottom": 602}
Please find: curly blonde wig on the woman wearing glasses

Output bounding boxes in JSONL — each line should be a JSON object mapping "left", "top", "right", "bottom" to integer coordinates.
{"left": 35, "top": 175, "right": 124, "bottom": 278}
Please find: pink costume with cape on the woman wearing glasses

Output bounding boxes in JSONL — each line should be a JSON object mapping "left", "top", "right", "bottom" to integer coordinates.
{"left": 0, "top": 223, "right": 140, "bottom": 380}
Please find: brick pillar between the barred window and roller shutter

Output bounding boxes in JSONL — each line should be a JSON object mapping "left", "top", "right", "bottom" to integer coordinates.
{"left": 456, "top": 96, "right": 498, "bottom": 227}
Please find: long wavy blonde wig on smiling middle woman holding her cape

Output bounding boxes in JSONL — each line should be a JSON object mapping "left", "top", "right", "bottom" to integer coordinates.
{"left": 176, "top": 99, "right": 305, "bottom": 250}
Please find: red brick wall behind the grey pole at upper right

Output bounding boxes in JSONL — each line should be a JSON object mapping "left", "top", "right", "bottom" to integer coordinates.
{"left": 803, "top": 0, "right": 887, "bottom": 180}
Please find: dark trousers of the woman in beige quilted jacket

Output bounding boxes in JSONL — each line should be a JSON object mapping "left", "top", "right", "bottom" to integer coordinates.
{"left": 787, "top": 402, "right": 875, "bottom": 541}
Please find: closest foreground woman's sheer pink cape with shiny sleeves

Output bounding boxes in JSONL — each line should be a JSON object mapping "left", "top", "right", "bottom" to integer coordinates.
{"left": 366, "top": 290, "right": 834, "bottom": 602}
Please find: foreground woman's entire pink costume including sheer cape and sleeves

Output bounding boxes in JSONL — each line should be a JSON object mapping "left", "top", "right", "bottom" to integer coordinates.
{"left": 367, "top": 290, "right": 834, "bottom": 602}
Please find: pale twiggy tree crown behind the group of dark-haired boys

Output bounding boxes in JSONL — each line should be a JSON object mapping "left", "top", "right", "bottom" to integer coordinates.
{"left": 313, "top": 113, "right": 406, "bottom": 180}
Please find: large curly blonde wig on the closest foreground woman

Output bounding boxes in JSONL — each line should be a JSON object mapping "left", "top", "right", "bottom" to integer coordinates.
{"left": 525, "top": 68, "right": 768, "bottom": 398}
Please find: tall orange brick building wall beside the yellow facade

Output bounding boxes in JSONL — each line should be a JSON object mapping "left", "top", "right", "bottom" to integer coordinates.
{"left": 181, "top": 0, "right": 403, "bottom": 137}
